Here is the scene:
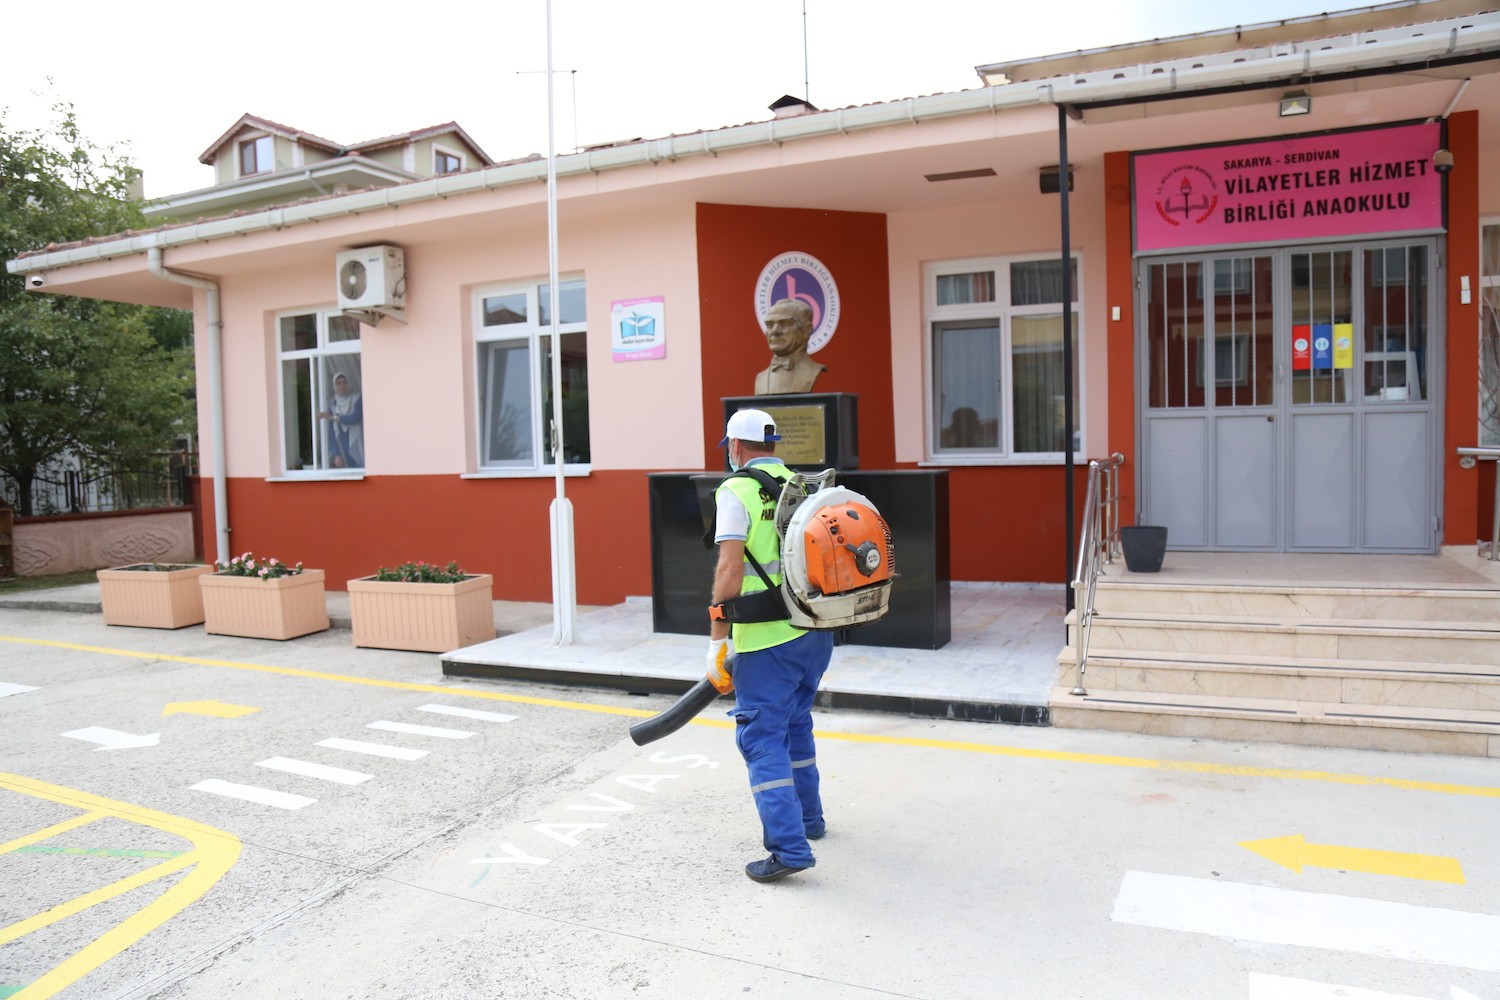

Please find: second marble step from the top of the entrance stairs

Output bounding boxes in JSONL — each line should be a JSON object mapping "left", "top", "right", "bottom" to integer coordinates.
{"left": 1068, "top": 613, "right": 1500, "bottom": 664}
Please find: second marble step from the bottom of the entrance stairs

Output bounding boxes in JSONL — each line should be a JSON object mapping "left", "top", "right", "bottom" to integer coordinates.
{"left": 1058, "top": 646, "right": 1500, "bottom": 712}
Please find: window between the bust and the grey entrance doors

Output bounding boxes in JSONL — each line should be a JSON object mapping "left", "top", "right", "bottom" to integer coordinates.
{"left": 927, "top": 256, "right": 1080, "bottom": 460}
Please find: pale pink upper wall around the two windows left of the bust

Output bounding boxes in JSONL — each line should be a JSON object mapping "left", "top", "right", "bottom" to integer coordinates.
{"left": 198, "top": 205, "right": 704, "bottom": 478}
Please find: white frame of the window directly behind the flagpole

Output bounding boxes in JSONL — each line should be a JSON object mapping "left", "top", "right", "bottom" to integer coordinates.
{"left": 464, "top": 274, "right": 593, "bottom": 478}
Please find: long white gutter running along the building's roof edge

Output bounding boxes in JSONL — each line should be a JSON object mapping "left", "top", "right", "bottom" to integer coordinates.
{"left": 6, "top": 13, "right": 1500, "bottom": 274}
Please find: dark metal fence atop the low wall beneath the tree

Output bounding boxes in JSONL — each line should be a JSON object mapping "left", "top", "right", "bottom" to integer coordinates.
{"left": 0, "top": 451, "right": 198, "bottom": 516}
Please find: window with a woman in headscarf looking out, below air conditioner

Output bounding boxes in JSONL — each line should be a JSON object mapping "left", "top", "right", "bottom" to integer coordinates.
{"left": 276, "top": 309, "right": 365, "bottom": 472}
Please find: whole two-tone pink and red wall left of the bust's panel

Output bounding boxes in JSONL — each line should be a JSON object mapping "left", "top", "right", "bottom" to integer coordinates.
{"left": 198, "top": 199, "right": 705, "bottom": 603}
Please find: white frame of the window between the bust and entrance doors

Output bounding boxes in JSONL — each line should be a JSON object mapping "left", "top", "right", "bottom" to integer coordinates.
{"left": 918, "top": 252, "right": 1088, "bottom": 466}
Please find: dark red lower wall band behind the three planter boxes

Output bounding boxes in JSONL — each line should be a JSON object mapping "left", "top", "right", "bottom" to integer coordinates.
{"left": 203, "top": 472, "right": 651, "bottom": 604}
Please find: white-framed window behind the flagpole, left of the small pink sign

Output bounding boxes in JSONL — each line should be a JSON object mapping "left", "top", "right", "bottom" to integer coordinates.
{"left": 474, "top": 279, "right": 590, "bottom": 471}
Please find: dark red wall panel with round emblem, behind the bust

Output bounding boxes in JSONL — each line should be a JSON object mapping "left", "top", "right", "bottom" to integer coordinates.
{"left": 693, "top": 204, "right": 896, "bottom": 469}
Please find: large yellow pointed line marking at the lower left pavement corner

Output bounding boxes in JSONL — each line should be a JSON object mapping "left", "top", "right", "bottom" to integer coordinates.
{"left": 0, "top": 772, "right": 240, "bottom": 1000}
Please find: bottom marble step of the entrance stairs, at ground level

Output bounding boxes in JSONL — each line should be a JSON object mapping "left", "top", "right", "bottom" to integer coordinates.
{"left": 1049, "top": 687, "right": 1500, "bottom": 757}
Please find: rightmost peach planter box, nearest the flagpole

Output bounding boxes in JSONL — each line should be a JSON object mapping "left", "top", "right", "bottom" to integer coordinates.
{"left": 348, "top": 573, "right": 495, "bottom": 652}
